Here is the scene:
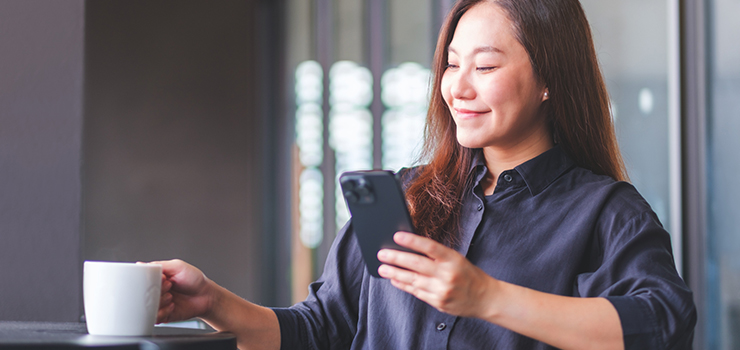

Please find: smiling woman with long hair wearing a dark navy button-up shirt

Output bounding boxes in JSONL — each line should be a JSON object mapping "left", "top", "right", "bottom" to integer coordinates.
{"left": 159, "top": 0, "right": 696, "bottom": 349}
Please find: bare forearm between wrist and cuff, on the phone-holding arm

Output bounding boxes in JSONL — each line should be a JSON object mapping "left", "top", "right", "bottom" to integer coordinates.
{"left": 481, "top": 279, "right": 624, "bottom": 349}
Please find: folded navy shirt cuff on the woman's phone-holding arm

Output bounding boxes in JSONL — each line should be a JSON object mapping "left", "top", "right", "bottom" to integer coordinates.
{"left": 606, "top": 296, "right": 663, "bottom": 350}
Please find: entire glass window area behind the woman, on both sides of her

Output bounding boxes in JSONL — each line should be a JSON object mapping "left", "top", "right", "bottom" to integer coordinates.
{"left": 286, "top": 0, "right": 740, "bottom": 349}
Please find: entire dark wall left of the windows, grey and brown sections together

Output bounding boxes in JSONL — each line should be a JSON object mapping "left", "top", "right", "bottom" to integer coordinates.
{"left": 0, "top": 0, "right": 292, "bottom": 321}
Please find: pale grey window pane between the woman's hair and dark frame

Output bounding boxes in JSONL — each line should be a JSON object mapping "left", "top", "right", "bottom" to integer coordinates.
{"left": 581, "top": 0, "right": 682, "bottom": 271}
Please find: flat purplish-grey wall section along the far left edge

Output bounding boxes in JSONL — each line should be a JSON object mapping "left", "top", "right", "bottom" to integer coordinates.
{"left": 0, "top": 0, "right": 84, "bottom": 321}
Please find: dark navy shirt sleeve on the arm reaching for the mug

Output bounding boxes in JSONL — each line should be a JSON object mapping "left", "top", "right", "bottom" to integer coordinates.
{"left": 273, "top": 222, "right": 365, "bottom": 349}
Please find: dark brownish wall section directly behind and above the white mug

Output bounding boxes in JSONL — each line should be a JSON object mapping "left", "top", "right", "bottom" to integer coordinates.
{"left": 83, "top": 0, "right": 275, "bottom": 302}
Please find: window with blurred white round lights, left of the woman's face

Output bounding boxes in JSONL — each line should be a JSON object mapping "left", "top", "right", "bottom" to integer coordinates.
{"left": 287, "top": 0, "right": 442, "bottom": 301}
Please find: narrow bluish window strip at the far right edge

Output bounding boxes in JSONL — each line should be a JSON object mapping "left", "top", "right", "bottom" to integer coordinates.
{"left": 704, "top": 0, "right": 740, "bottom": 349}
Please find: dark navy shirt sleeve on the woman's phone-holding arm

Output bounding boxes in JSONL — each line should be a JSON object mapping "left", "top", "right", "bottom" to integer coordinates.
{"left": 576, "top": 191, "right": 696, "bottom": 349}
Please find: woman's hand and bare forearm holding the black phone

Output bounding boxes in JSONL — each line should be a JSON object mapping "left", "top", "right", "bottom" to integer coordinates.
{"left": 378, "top": 232, "right": 624, "bottom": 349}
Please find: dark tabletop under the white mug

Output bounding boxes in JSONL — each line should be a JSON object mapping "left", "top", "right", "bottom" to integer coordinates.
{"left": 0, "top": 321, "right": 236, "bottom": 350}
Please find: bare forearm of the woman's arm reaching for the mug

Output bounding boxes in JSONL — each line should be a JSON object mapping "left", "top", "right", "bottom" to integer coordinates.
{"left": 202, "top": 281, "right": 280, "bottom": 350}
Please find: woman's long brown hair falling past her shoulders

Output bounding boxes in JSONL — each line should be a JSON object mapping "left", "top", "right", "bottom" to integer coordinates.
{"left": 406, "top": 0, "right": 627, "bottom": 245}
